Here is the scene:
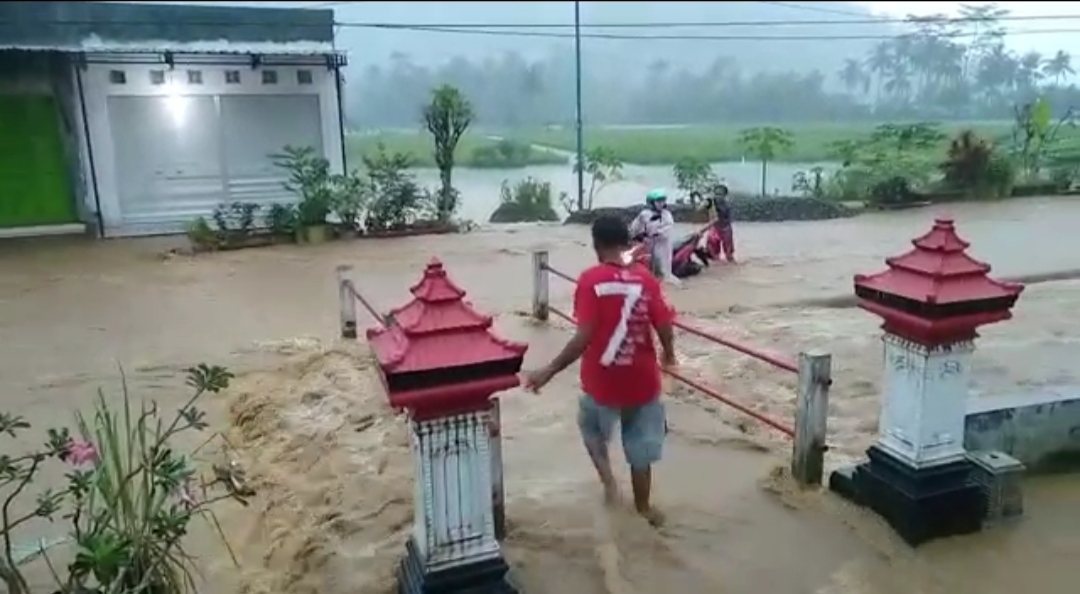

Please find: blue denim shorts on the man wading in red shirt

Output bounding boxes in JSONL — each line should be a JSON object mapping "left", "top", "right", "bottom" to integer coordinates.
{"left": 578, "top": 394, "right": 667, "bottom": 470}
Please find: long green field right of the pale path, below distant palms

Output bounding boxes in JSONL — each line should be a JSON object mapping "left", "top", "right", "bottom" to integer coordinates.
{"left": 511, "top": 121, "right": 1011, "bottom": 165}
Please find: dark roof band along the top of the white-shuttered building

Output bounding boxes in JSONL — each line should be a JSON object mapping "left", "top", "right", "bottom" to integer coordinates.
{"left": 0, "top": 1, "right": 334, "bottom": 54}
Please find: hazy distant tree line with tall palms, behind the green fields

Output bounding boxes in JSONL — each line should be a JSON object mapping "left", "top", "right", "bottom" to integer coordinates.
{"left": 347, "top": 4, "right": 1080, "bottom": 127}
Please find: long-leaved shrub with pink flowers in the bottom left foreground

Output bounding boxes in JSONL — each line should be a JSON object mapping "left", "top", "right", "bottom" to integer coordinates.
{"left": 0, "top": 365, "right": 254, "bottom": 594}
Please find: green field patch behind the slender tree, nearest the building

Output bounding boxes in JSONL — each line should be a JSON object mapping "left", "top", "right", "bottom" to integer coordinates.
{"left": 346, "top": 131, "right": 567, "bottom": 168}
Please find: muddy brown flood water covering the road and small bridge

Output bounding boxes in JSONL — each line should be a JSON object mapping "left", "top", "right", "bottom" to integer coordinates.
{"left": 0, "top": 199, "right": 1080, "bottom": 594}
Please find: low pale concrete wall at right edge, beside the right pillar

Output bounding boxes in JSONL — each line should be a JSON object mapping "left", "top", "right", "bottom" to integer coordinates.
{"left": 963, "top": 388, "right": 1080, "bottom": 472}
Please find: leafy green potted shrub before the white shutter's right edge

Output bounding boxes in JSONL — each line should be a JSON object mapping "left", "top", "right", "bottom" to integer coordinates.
{"left": 271, "top": 146, "right": 333, "bottom": 243}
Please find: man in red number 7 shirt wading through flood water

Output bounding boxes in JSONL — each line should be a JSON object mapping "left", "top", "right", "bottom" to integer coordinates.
{"left": 525, "top": 217, "right": 675, "bottom": 525}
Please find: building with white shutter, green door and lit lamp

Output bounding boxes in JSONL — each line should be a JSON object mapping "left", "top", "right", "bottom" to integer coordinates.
{"left": 0, "top": 1, "right": 345, "bottom": 237}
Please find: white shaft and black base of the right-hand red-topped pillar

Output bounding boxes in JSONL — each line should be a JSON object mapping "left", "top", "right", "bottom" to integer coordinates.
{"left": 829, "top": 334, "right": 986, "bottom": 546}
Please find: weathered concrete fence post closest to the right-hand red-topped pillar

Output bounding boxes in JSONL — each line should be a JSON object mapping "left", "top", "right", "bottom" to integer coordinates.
{"left": 792, "top": 353, "right": 833, "bottom": 486}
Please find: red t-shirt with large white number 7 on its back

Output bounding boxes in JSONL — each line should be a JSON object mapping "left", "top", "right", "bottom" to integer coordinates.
{"left": 573, "top": 262, "right": 675, "bottom": 407}
